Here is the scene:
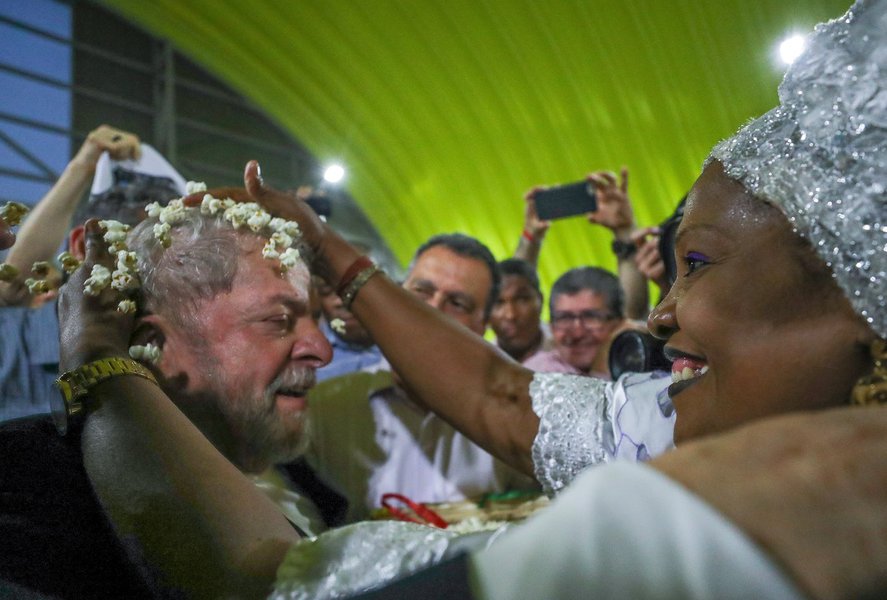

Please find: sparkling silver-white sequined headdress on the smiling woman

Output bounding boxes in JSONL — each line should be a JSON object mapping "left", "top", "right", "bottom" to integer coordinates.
{"left": 709, "top": 0, "right": 887, "bottom": 338}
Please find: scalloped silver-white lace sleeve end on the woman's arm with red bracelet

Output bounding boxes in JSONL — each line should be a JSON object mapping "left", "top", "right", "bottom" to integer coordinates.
{"left": 530, "top": 373, "right": 614, "bottom": 496}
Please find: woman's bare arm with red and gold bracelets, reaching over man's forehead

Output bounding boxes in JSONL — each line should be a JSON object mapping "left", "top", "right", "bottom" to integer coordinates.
{"left": 244, "top": 161, "right": 539, "bottom": 474}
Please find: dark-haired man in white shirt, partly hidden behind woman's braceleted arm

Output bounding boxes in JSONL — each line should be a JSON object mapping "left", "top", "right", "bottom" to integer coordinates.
{"left": 307, "top": 234, "right": 538, "bottom": 520}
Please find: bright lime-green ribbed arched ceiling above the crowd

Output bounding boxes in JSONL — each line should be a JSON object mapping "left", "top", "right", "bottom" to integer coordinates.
{"left": 105, "top": 0, "right": 850, "bottom": 285}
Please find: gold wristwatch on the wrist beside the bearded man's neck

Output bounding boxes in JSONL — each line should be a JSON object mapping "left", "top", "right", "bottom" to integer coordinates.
{"left": 50, "top": 358, "right": 157, "bottom": 435}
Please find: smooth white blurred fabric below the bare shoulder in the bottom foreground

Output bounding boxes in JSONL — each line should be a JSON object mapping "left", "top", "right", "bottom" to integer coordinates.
{"left": 470, "top": 462, "right": 803, "bottom": 600}
